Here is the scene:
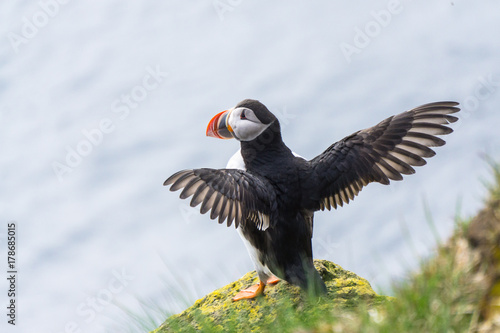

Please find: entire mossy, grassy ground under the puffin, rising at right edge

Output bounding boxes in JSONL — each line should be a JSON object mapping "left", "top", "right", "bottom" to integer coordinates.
{"left": 148, "top": 163, "right": 500, "bottom": 333}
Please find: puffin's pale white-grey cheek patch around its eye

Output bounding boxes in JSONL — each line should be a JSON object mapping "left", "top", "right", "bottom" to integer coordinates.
{"left": 226, "top": 107, "right": 271, "bottom": 141}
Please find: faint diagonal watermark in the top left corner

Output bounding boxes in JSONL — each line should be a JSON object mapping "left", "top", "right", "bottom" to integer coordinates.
{"left": 7, "top": 0, "right": 69, "bottom": 53}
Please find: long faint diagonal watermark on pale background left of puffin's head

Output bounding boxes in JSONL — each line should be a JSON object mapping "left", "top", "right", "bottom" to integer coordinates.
{"left": 52, "top": 65, "right": 168, "bottom": 182}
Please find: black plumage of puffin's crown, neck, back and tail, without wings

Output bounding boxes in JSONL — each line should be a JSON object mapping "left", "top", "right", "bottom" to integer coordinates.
{"left": 232, "top": 99, "right": 326, "bottom": 295}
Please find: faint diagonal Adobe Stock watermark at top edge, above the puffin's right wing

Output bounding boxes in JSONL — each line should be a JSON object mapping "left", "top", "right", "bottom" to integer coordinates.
{"left": 339, "top": 0, "right": 410, "bottom": 63}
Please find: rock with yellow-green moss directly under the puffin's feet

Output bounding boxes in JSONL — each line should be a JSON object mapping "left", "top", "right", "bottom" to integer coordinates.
{"left": 154, "top": 260, "right": 390, "bottom": 333}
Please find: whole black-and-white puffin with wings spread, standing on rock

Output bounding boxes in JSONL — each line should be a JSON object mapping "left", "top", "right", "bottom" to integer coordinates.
{"left": 163, "top": 99, "right": 460, "bottom": 301}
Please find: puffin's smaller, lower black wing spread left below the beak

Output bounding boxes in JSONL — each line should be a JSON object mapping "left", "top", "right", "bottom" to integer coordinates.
{"left": 163, "top": 168, "right": 276, "bottom": 230}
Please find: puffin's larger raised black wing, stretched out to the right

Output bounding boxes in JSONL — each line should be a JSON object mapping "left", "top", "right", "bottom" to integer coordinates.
{"left": 304, "top": 102, "right": 460, "bottom": 210}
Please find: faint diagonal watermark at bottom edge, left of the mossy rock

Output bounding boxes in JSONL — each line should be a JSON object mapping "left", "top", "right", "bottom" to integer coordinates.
{"left": 60, "top": 268, "right": 135, "bottom": 333}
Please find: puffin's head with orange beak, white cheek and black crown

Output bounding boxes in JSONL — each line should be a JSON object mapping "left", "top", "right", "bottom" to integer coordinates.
{"left": 207, "top": 99, "right": 280, "bottom": 141}
